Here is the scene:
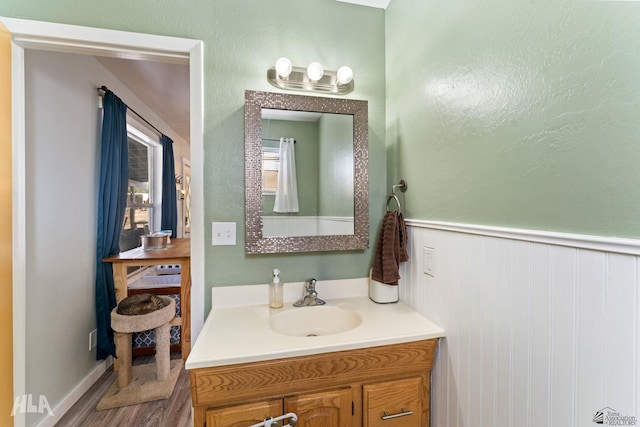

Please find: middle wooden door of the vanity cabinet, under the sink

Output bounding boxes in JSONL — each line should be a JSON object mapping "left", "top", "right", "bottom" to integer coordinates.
{"left": 284, "top": 388, "right": 352, "bottom": 427}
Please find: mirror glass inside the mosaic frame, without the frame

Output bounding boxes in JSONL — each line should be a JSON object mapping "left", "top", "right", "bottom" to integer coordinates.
{"left": 262, "top": 108, "right": 354, "bottom": 237}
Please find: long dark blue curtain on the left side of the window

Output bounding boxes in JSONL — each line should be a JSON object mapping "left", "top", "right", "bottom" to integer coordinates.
{"left": 95, "top": 90, "right": 129, "bottom": 360}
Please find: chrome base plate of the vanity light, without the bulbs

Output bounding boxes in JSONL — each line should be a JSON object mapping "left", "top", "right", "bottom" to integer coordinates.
{"left": 267, "top": 67, "right": 354, "bottom": 95}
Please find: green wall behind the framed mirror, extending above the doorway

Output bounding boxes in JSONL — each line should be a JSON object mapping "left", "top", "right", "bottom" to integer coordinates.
{"left": 0, "top": 0, "right": 386, "bottom": 312}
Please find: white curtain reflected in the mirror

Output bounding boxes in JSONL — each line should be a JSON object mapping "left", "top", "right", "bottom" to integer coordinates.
{"left": 273, "top": 138, "right": 299, "bottom": 213}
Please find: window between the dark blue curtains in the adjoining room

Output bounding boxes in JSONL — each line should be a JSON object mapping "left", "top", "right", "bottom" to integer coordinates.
{"left": 120, "top": 126, "right": 161, "bottom": 251}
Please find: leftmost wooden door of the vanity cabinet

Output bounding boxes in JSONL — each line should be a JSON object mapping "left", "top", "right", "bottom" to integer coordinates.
{"left": 207, "top": 399, "right": 282, "bottom": 427}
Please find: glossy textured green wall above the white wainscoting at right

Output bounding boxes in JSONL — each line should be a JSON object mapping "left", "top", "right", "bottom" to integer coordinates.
{"left": 385, "top": 0, "right": 640, "bottom": 238}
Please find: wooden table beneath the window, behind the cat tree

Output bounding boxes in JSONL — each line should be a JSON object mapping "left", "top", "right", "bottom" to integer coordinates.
{"left": 102, "top": 239, "right": 191, "bottom": 360}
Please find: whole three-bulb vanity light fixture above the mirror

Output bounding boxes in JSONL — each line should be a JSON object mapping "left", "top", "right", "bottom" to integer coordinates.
{"left": 267, "top": 58, "right": 354, "bottom": 95}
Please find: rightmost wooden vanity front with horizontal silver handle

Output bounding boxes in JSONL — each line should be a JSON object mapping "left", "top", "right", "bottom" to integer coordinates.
{"left": 362, "top": 377, "right": 422, "bottom": 427}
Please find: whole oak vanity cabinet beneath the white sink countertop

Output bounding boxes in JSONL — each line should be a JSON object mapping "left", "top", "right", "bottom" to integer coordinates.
{"left": 190, "top": 339, "right": 437, "bottom": 427}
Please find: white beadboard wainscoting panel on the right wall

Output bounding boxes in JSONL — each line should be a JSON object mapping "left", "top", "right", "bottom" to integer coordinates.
{"left": 400, "top": 225, "right": 640, "bottom": 427}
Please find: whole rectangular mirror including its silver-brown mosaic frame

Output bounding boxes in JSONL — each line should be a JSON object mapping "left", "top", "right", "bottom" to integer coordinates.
{"left": 245, "top": 91, "right": 369, "bottom": 254}
